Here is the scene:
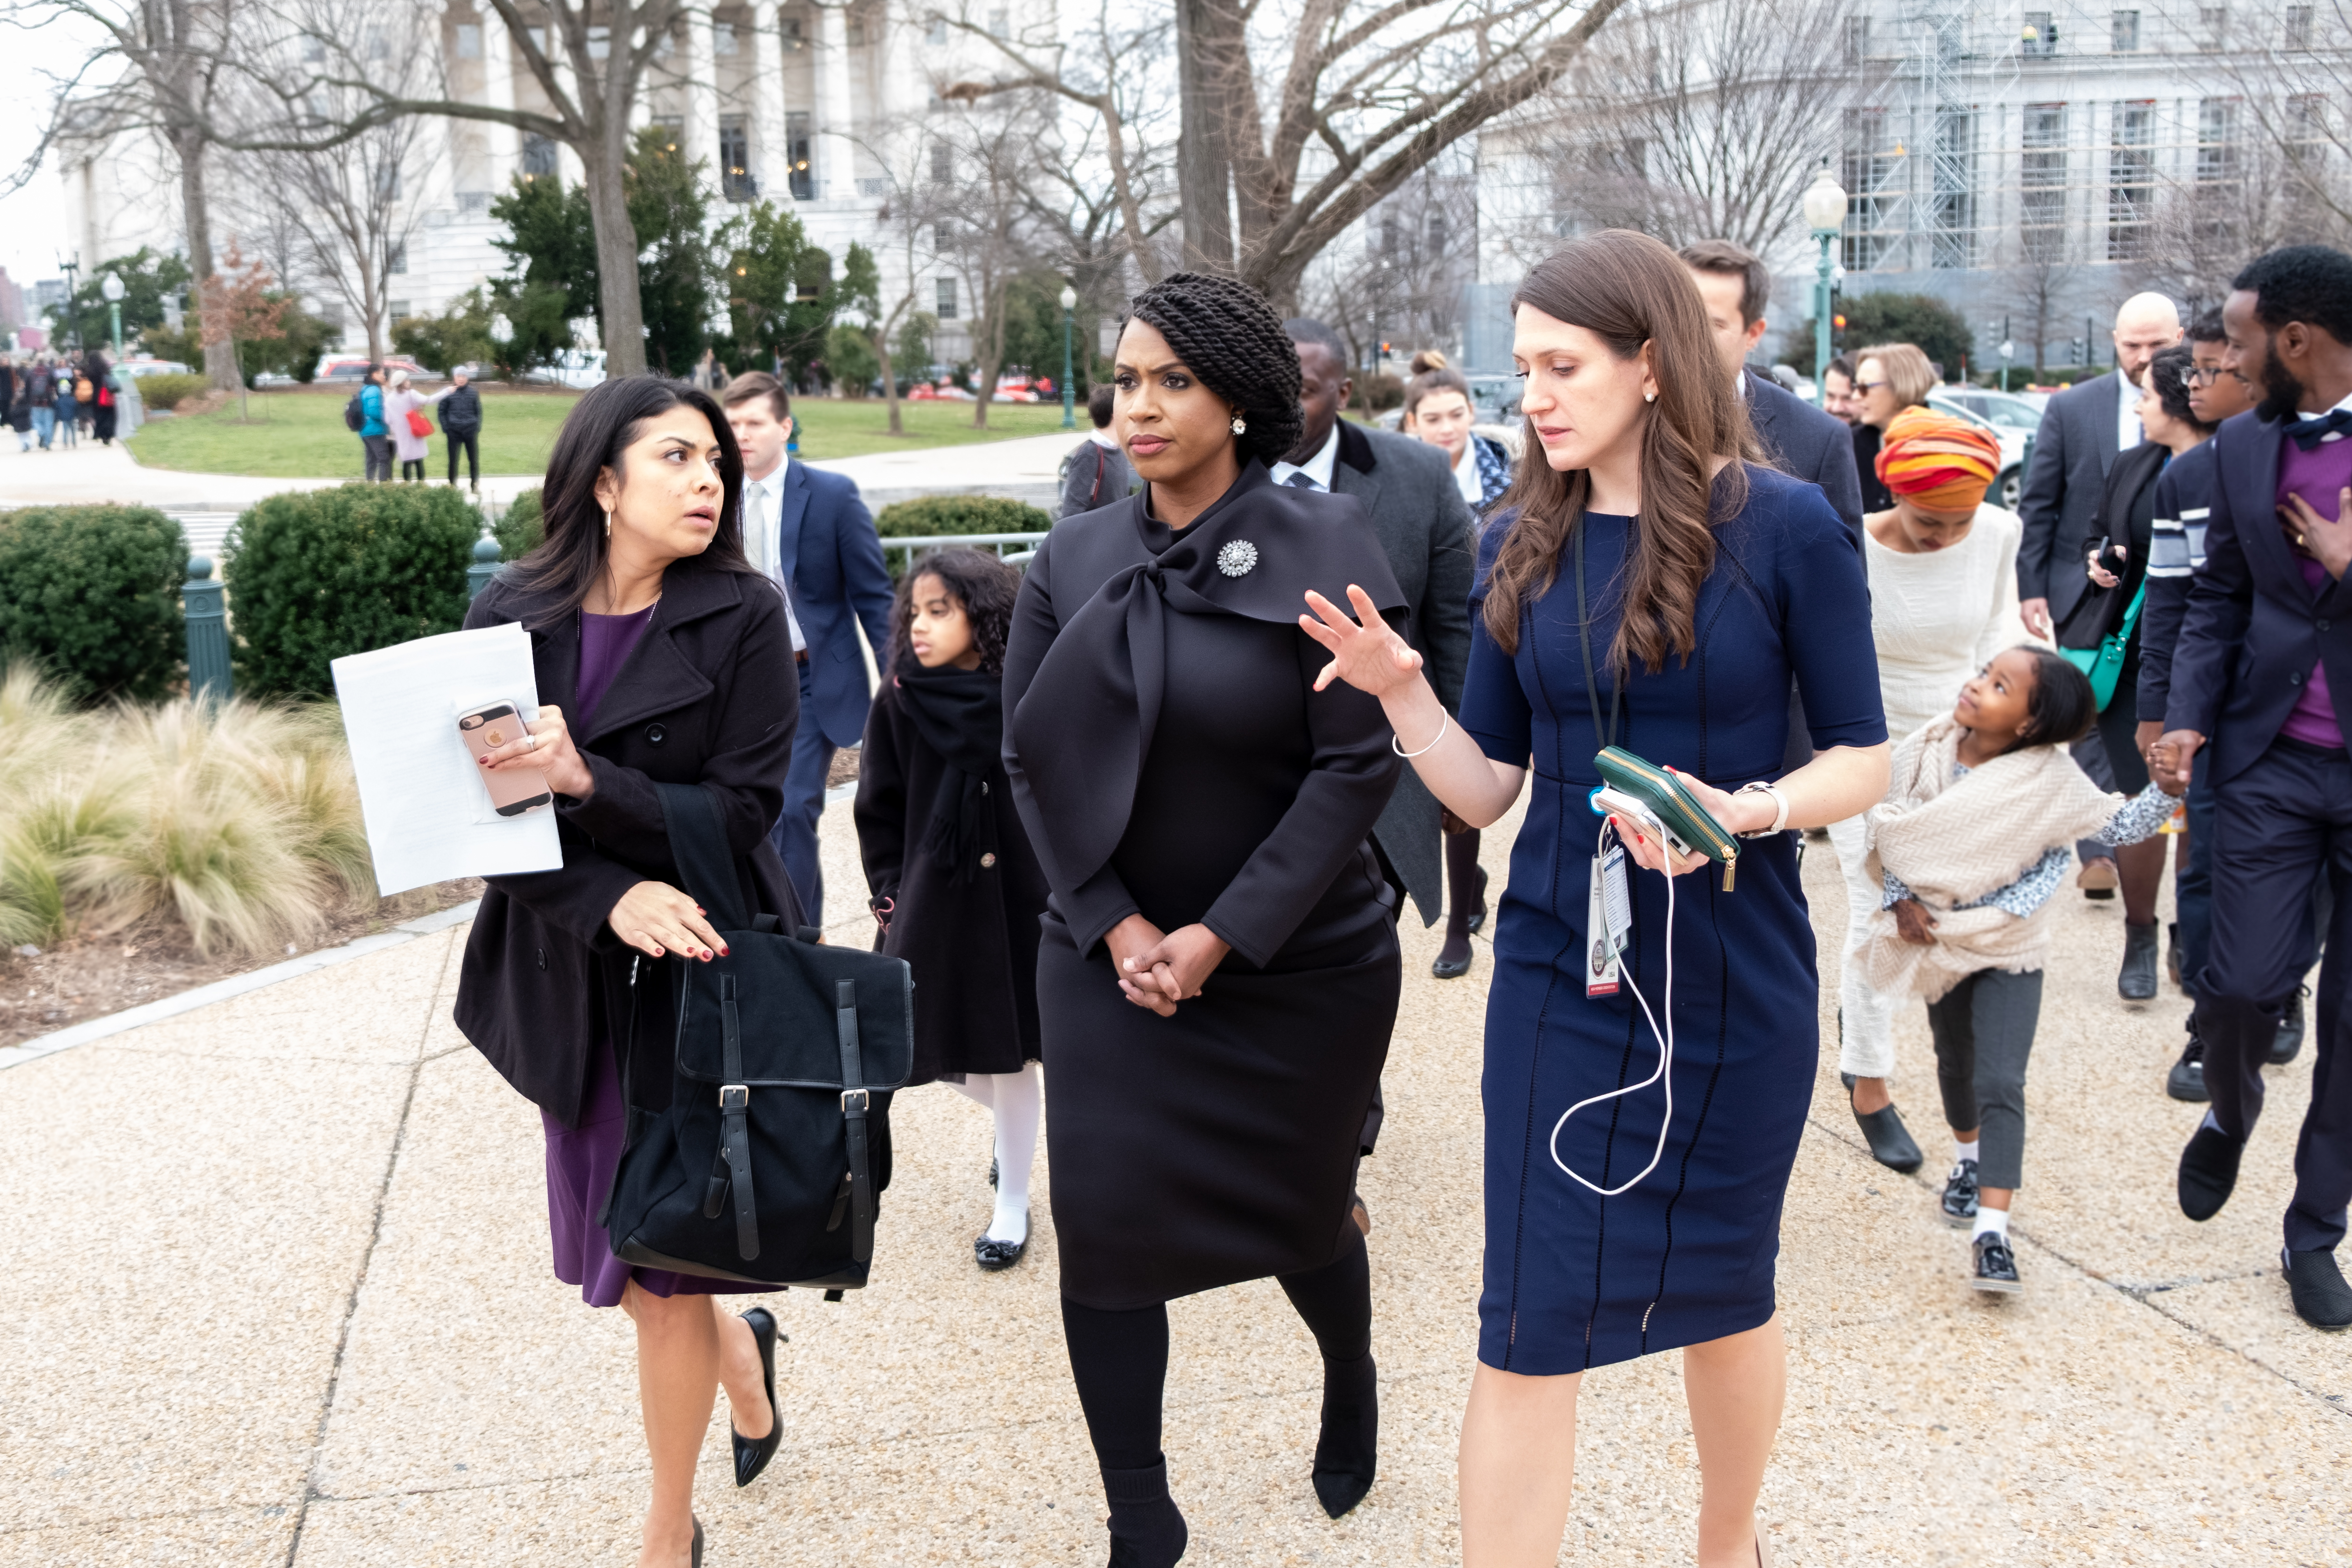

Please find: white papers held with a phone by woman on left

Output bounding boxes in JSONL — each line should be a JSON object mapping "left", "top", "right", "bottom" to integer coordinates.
{"left": 334, "top": 623, "right": 565, "bottom": 893}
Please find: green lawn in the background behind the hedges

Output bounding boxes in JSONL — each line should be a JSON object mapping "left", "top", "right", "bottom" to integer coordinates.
{"left": 129, "top": 388, "right": 1061, "bottom": 479}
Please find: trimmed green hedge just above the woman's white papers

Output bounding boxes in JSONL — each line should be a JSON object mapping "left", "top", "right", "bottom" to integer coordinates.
{"left": 223, "top": 484, "right": 482, "bottom": 696}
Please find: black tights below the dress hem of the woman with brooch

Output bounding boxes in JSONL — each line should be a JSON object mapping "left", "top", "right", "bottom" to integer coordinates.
{"left": 1061, "top": 1222, "right": 1371, "bottom": 1469}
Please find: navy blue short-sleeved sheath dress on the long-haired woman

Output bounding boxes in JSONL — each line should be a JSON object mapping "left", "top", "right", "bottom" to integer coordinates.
{"left": 1461, "top": 468, "right": 1886, "bottom": 1375}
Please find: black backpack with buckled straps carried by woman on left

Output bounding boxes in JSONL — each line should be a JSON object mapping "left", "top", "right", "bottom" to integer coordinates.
{"left": 602, "top": 783, "right": 915, "bottom": 1300}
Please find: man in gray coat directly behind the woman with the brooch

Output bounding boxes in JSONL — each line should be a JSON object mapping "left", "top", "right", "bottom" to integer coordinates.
{"left": 1275, "top": 317, "right": 1477, "bottom": 1232}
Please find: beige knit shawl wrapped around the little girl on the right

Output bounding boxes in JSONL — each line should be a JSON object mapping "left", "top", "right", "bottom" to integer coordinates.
{"left": 1853, "top": 715, "right": 2124, "bottom": 1001}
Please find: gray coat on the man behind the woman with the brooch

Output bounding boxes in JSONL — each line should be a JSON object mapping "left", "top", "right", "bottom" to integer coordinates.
{"left": 1331, "top": 419, "right": 1477, "bottom": 926}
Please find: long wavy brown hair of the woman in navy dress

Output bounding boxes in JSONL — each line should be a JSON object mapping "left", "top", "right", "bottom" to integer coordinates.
{"left": 1486, "top": 228, "right": 1759, "bottom": 677}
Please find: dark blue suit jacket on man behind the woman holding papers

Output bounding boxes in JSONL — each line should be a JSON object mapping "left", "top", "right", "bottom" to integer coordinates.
{"left": 776, "top": 458, "right": 891, "bottom": 745}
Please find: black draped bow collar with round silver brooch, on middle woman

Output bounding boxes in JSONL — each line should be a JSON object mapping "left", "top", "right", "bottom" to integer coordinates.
{"left": 1011, "top": 461, "right": 1407, "bottom": 889}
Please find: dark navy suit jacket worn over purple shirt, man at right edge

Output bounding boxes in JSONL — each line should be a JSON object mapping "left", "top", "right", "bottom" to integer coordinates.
{"left": 2164, "top": 414, "right": 2352, "bottom": 788}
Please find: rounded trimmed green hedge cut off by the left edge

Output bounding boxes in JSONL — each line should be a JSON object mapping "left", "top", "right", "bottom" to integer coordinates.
{"left": 0, "top": 505, "right": 188, "bottom": 703}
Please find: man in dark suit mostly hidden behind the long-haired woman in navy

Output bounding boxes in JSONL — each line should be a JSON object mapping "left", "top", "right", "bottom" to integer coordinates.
{"left": 1682, "top": 240, "right": 1870, "bottom": 771}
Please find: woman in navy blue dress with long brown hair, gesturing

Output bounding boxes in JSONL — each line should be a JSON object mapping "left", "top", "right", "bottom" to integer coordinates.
{"left": 1303, "top": 230, "right": 1886, "bottom": 1568}
